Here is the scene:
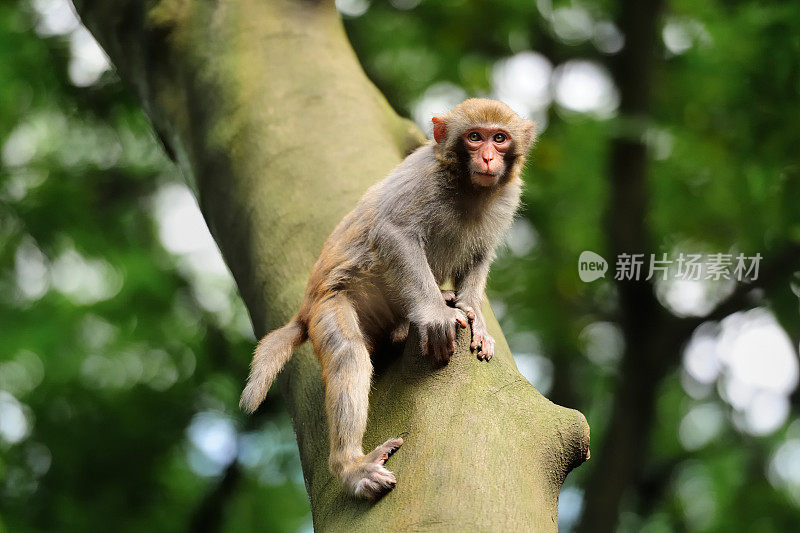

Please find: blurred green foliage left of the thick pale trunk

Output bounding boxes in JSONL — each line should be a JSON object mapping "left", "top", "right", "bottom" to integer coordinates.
{"left": 0, "top": 2, "right": 309, "bottom": 531}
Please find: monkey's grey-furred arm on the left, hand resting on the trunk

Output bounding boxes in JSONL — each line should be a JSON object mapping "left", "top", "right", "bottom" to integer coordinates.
{"left": 373, "top": 223, "right": 469, "bottom": 363}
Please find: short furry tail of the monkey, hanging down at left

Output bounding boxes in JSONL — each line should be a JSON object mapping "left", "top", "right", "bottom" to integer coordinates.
{"left": 239, "top": 315, "right": 308, "bottom": 413}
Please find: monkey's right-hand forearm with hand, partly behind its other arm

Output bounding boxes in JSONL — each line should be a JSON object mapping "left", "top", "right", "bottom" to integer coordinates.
{"left": 455, "top": 255, "right": 494, "bottom": 361}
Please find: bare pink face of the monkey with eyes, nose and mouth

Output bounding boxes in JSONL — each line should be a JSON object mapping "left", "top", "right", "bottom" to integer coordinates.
{"left": 462, "top": 127, "right": 511, "bottom": 187}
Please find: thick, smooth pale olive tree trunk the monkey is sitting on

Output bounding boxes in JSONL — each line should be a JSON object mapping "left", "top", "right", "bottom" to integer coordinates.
{"left": 75, "top": 0, "right": 589, "bottom": 531}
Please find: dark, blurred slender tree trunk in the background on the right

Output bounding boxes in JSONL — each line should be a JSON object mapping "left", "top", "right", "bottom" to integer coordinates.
{"left": 577, "top": 0, "right": 664, "bottom": 533}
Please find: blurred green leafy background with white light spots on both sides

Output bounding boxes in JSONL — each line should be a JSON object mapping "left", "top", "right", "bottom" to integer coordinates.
{"left": 0, "top": 0, "right": 800, "bottom": 532}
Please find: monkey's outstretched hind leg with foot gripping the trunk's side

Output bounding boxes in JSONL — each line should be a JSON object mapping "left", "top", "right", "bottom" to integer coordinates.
{"left": 309, "top": 294, "right": 403, "bottom": 499}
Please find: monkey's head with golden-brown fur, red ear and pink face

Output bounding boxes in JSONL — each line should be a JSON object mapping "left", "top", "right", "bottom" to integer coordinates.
{"left": 433, "top": 98, "right": 534, "bottom": 188}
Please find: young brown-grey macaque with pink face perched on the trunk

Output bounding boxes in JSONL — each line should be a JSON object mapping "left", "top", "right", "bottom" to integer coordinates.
{"left": 240, "top": 99, "right": 534, "bottom": 499}
